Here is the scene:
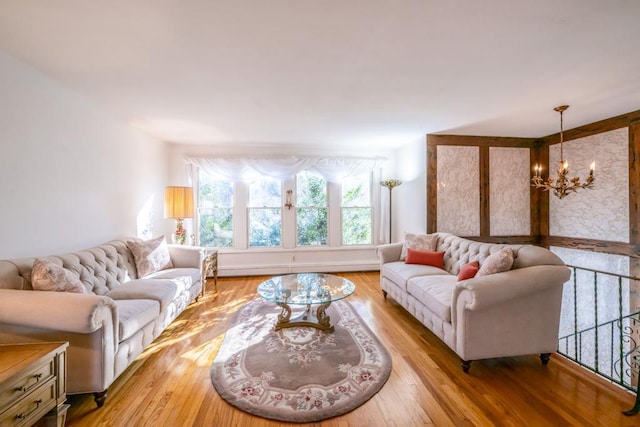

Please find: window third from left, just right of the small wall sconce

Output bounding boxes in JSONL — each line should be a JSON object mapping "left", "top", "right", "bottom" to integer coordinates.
{"left": 296, "top": 171, "right": 328, "bottom": 246}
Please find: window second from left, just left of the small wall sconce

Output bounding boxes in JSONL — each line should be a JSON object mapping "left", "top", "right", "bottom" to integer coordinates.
{"left": 248, "top": 178, "right": 282, "bottom": 246}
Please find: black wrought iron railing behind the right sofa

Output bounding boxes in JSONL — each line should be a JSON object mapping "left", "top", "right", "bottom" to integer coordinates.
{"left": 558, "top": 265, "right": 640, "bottom": 415}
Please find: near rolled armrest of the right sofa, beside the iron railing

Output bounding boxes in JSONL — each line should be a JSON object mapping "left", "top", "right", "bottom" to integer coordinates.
{"left": 451, "top": 265, "right": 571, "bottom": 317}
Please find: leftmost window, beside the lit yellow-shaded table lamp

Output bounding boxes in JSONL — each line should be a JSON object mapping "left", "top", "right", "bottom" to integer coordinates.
{"left": 198, "top": 172, "right": 233, "bottom": 247}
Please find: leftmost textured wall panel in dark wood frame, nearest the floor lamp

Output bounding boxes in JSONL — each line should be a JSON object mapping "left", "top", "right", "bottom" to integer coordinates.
{"left": 438, "top": 146, "right": 480, "bottom": 236}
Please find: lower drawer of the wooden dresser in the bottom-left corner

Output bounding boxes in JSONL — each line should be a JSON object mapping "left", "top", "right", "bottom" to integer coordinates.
{"left": 0, "top": 378, "right": 56, "bottom": 427}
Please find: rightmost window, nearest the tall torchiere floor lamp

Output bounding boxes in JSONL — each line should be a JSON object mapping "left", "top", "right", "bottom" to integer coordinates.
{"left": 342, "top": 173, "right": 373, "bottom": 245}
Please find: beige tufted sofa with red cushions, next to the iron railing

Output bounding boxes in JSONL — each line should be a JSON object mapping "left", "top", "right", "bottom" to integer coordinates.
{"left": 377, "top": 233, "right": 570, "bottom": 372}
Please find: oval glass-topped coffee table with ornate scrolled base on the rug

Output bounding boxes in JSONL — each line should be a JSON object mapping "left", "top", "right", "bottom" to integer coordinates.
{"left": 258, "top": 273, "right": 356, "bottom": 332}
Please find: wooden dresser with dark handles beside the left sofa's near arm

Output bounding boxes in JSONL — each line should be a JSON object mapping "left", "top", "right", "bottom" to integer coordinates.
{"left": 0, "top": 342, "right": 69, "bottom": 427}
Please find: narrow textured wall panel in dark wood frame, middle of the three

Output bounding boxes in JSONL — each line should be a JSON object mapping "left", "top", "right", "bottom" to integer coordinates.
{"left": 489, "top": 147, "right": 531, "bottom": 236}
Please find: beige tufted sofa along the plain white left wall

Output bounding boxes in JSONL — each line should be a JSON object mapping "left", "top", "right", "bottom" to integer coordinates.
{"left": 0, "top": 239, "right": 203, "bottom": 407}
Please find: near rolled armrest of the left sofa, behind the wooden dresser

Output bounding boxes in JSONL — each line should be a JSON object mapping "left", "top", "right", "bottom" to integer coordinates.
{"left": 0, "top": 289, "right": 118, "bottom": 336}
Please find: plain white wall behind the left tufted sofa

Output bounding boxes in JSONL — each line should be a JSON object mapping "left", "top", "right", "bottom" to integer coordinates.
{"left": 0, "top": 53, "right": 168, "bottom": 258}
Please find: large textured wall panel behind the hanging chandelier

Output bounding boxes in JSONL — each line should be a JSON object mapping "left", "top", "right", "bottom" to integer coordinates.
{"left": 543, "top": 128, "right": 629, "bottom": 242}
